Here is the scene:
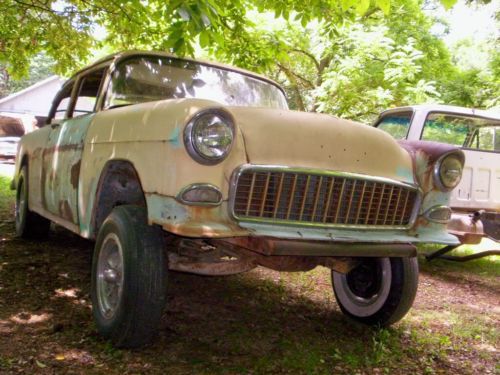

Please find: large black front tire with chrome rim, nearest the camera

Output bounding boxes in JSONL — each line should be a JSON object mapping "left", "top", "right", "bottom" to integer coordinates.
{"left": 91, "top": 205, "right": 168, "bottom": 348}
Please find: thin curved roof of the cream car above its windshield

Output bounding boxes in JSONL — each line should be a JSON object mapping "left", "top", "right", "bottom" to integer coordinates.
{"left": 70, "top": 50, "right": 285, "bottom": 94}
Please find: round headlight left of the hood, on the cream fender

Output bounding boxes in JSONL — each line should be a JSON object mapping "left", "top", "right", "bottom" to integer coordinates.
{"left": 184, "top": 109, "right": 234, "bottom": 164}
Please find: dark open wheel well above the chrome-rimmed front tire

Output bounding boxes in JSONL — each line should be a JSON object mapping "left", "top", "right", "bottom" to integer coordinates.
{"left": 92, "top": 160, "right": 146, "bottom": 237}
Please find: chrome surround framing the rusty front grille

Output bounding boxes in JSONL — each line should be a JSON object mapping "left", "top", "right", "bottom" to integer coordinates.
{"left": 228, "top": 164, "right": 423, "bottom": 230}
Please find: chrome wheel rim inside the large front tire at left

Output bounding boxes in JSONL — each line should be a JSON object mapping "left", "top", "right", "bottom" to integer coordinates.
{"left": 96, "top": 233, "right": 123, "bottom": 319}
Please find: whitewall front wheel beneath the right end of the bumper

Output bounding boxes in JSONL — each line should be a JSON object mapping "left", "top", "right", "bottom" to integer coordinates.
{"left": 332, "top": 257, "right": 418, "bottom": 327}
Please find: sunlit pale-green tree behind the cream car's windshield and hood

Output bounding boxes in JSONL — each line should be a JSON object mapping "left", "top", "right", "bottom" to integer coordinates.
{"left": 212, "top": 0, "right": 454, "bottom": 121}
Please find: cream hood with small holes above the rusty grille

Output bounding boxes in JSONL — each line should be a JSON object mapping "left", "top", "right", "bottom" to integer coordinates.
{"left": 228, "top": 107, "right": 414, "bottom": 183}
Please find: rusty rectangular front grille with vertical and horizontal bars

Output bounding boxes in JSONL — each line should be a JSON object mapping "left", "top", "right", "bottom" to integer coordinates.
{"left": 232, "top": 166, "right": 418, "bottom": 227}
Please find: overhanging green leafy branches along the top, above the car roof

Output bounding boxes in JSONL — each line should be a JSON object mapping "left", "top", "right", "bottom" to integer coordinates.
{"left": 0, "top": 0, "right": 456, "bottom": 77}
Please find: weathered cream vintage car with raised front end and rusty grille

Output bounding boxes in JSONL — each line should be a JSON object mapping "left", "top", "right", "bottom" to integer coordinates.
{"left": 13, "top": 52, "right": 464, "bottom": 347}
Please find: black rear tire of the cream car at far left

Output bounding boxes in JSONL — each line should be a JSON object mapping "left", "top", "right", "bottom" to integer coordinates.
{"left": 15, "top": 166, "right": 50, "bottom": 239}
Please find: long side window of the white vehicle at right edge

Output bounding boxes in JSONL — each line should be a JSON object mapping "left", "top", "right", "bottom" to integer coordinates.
{"left": 421, "top": 113, "right": 500, "bottom": 151}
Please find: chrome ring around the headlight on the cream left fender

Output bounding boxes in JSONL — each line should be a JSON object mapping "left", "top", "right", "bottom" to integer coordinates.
{"left": 184, "top": 108, "right": 235, "bottom": 165}
